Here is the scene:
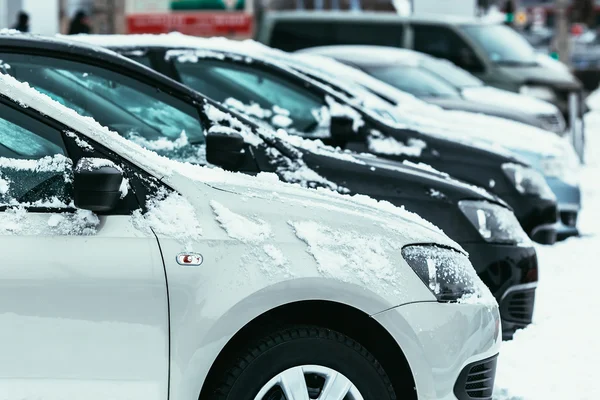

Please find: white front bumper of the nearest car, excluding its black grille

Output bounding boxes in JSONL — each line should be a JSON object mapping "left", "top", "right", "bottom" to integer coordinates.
{"left": 373, "top": 302, "right": 501, "bottom": 400}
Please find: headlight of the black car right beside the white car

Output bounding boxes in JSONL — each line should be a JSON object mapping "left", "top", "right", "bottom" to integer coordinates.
{"left": 458, "top": 200, "right": 530, "bottom": 244}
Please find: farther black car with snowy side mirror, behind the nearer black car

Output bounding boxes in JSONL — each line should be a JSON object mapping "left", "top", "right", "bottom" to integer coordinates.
{"left": 74, "top": 38, "right": 558, "bottom": 244}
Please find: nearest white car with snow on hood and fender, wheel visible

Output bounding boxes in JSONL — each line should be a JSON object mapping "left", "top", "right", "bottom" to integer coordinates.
{"left": 0, "top": 74, "right": 501, "bottom": 400}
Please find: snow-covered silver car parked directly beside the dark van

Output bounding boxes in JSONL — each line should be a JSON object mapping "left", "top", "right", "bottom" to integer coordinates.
{"left": 301, "top": 46, "right": 566, "bottom": 135}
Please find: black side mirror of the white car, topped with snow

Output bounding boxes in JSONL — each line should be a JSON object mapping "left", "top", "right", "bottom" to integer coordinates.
{"left": 73, "top": 158, "right": 123, "bottom": 212}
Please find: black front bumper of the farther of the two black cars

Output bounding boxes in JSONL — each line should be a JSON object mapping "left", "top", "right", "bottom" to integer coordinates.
{"left": 500, "top": 195, "right": 558, "bottom": 244}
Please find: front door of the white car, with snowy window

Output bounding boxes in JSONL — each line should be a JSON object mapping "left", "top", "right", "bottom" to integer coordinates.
{"left": 0, "top": 97, "right": 169, "bottom": 400}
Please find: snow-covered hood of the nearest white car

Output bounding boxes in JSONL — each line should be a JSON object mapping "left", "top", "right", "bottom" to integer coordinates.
{"left": 165, "top": 165, "right": 461, "bottom": 249}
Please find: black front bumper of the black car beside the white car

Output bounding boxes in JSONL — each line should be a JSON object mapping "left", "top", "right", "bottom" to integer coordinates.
{"left": 460, "top": 242, "right": 538, "bottom": 339}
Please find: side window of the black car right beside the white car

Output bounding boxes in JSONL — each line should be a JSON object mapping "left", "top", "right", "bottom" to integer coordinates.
{"left": 0, "top": 54, "right": 205, "bottom": 163}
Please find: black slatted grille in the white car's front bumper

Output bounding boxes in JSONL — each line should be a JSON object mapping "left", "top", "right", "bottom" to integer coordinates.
{"left": 454, "top": 356, "right": 498, "bottom": 400}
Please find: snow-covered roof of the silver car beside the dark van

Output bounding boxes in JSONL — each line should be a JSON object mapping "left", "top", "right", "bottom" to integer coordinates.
{"left": 298, "top": 45, "right": 426, "bottom": 67}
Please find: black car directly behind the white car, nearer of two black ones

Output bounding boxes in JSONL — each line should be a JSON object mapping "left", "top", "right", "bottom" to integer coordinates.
{"left": 0, "top": 35, "right": 537, "bottom": 338}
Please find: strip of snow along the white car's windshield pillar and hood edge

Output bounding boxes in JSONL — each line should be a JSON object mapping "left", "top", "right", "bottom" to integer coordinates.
{"left": 0, "top": 74, "right": 452, "bottom": 249}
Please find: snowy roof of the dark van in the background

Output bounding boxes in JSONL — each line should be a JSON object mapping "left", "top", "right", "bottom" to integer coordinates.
{"left": 265, "top": 11, "right": 493, "bottom": 25}
